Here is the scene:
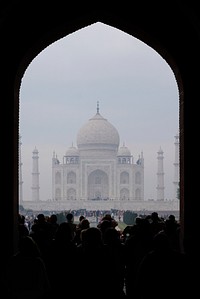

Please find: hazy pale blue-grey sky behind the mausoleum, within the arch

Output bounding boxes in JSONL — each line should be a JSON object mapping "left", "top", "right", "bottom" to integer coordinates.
{"left": 20, "top": 23, "right": 179, "bottom": 200}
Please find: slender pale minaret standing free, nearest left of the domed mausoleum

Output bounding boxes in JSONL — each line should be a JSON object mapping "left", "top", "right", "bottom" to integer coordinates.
{"left": 32, "top": 147, "right": 40, "bottom": 202}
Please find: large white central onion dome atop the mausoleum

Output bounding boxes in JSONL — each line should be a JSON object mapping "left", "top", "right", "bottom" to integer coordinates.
{"left": 77, "top": 108, "right": 119, "bottom": 150}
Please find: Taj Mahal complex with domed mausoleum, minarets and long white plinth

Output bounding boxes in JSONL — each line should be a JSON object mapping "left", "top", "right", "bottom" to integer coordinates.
{"left": 19, "top": 102, "right": 179, "bottom": 216}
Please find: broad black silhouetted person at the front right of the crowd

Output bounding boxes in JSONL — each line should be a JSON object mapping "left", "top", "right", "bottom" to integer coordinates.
{"left": 135, "top": 231, "right": 188, "bottom": 299}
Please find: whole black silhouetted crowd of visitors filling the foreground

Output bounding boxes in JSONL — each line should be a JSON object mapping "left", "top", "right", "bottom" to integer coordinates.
{"left": 5, "top": 212, "right": 193, "bottom": 299}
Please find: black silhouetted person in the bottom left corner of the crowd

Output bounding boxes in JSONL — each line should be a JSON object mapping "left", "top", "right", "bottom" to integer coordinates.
{"left": 7, "top": 236, "right": 51, "bottom": 299}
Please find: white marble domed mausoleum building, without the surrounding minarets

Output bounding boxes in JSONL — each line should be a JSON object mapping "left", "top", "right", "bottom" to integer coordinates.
{"left": 52, "top": 102, "right": 144, "bottom": 210}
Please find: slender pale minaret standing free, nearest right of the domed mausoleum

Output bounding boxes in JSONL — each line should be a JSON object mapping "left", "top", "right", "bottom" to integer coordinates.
{"left": 156, "top": 148, "right": 165, "bottom": 201}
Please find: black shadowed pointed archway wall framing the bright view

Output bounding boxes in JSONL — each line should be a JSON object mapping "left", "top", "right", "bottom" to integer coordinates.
{"left": 0, "top": 0, "right": 200, "bottom": 264}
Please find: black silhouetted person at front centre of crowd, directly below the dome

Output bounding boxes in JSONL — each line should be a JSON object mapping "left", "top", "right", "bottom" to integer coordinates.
{"left": 76, "top": 227, "right": 114, "bottom": 298}
